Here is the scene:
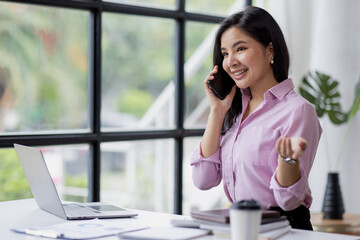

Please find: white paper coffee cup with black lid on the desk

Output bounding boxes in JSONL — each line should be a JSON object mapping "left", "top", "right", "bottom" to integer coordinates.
{"left": 230, "top": 200, "right": 261, "bottom": 240}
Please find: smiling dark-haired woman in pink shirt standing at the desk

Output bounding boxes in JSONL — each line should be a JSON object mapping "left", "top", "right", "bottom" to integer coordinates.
{"left": 191, "top": 7, "right": 322, "bottom": 230}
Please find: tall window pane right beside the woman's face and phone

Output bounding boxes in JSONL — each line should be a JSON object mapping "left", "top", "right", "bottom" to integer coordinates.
{"left": 184, "top": 22, "right": 216, "bottom": 128}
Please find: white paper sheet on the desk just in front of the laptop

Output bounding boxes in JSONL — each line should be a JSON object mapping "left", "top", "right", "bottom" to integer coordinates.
{"left": 12, "top": 219, "right": 147, "bottom": 239}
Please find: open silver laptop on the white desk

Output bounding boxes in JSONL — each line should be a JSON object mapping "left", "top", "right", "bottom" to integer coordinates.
{"left": 14, "top": 144, "right": 137, "bottom": 220}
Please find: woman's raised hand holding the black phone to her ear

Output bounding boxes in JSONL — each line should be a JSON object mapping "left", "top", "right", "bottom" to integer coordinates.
{"left": 204, "top": 65, "right": 236, "bottom": 115}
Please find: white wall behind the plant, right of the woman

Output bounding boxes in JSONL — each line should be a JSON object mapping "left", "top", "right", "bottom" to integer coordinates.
{"left": 264, "top": 0, "right": 360, "bottom": 214}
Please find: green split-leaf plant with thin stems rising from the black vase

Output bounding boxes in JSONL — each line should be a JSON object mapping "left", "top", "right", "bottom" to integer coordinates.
{"left": 300, "top": 71, "right": 360, "bottom": 170}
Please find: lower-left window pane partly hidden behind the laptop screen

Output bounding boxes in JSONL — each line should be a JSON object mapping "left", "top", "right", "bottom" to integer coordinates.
{"left": 0, "top": 145, "right": 90, "bottom": 202}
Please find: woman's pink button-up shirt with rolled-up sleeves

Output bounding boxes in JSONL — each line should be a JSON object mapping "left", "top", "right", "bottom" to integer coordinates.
{"left": 191, "top": 78, "right": 322, "bottom": 211}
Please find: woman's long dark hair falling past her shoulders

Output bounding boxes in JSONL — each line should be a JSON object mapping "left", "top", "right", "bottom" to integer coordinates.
{"left": 213, "top": 7, "right": 290, "bottom": 134}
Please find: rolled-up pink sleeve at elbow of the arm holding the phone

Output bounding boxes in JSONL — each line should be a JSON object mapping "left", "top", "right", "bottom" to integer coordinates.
{"left": 190, "top": 144, "right": 222, "bottom": 190}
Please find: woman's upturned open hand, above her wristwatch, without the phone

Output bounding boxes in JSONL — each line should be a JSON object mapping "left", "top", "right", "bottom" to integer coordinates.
{"left": 276, "top": 136, "right": 307, "bottom": 159}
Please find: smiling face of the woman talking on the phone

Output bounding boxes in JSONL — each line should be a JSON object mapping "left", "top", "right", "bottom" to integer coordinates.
{"left": 221, "top": 27, "right": 274, "bottom": 88}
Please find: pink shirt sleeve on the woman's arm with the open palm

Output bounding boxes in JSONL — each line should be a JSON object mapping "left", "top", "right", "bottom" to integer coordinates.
{"left": 270, "top": 104, "right": 322, "bottom": 211}
